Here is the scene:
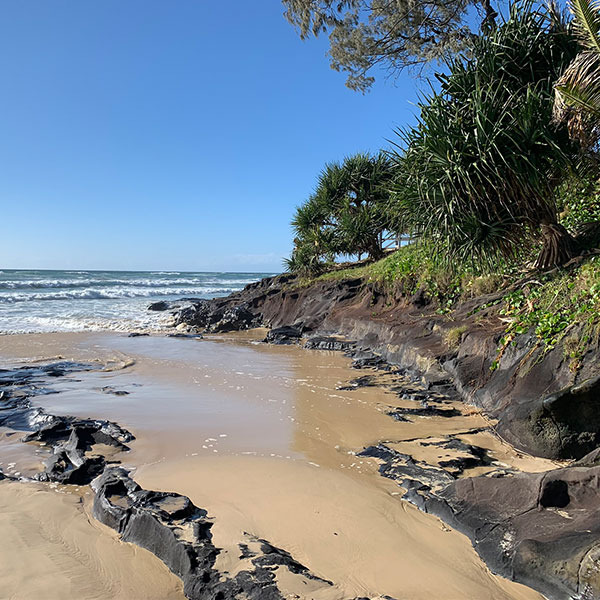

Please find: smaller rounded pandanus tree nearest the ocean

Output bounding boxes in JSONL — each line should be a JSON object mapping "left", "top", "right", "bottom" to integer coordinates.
{"left": 286, "top": 153, "right": 394, "bottom": 272}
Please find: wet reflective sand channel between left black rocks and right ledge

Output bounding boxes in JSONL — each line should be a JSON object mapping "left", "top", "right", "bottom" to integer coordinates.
{"left": 0, "top": 333, "right": 554, "bottom": 600}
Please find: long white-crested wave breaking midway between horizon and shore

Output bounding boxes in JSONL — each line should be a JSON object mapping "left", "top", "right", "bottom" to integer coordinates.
{"left": 0, "top": 287, "right": 239, "bottom": 304}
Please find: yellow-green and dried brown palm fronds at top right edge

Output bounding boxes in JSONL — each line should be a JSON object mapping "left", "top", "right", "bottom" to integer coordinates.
{"left": 554, "top": 0, "right": 600, "bottom": 148}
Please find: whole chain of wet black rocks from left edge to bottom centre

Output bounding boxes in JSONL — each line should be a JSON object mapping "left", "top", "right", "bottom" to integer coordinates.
{"left": 0, "top": 362, "right": 333, "bottom": 600}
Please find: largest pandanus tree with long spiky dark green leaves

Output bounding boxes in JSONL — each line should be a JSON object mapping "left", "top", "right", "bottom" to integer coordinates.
{"left": 395, "top": 3, "right": 576, "bottom": 267}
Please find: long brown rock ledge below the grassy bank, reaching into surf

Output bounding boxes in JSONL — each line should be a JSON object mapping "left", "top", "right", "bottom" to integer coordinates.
{"left": 168, "top": 275, "right": 600, "bottom": 458}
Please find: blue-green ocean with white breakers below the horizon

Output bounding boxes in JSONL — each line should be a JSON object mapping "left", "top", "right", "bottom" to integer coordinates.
{"left": 0, "top": 269, "right": 272, "bottom": 333}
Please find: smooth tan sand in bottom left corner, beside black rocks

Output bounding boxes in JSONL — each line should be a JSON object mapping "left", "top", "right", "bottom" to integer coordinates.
{"left": 0, "top": 482, "right": 184, "bottom": 600}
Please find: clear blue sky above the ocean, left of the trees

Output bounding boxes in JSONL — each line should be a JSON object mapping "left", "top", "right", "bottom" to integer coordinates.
{"left": 0, "top": 0, "right": 417, "bottom": 271}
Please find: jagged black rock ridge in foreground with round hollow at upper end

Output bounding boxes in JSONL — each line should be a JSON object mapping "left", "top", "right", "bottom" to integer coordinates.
{"left": 92, "top": 468, "right": 332, "bottom": 600}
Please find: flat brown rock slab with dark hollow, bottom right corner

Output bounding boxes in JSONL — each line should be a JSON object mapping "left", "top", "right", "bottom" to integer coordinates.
{"left": 361, "top": 444, "right": 600, "bottom": 600}
